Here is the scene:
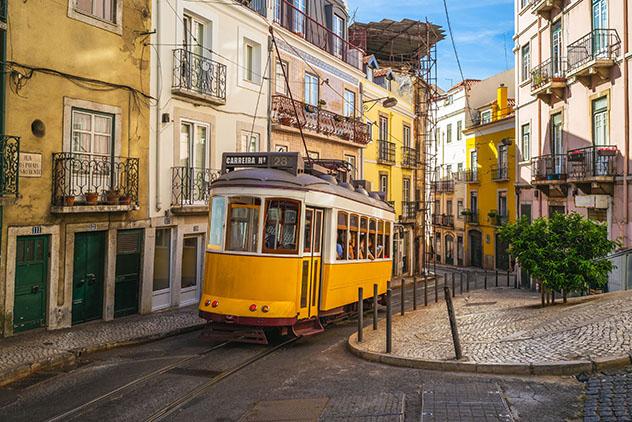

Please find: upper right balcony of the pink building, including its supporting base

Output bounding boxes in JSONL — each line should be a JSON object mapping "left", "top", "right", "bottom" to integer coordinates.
{"left": 567, "top": 29, "right": 621, "bottom": 86}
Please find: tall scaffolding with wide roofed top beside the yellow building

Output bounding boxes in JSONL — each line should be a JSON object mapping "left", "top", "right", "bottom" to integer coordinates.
{"left": 349, "top": 19, "right": 445, "bottom": 274}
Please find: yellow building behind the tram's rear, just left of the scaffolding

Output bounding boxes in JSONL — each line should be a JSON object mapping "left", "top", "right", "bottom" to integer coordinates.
{"left": 362, "top": 65, "right": 418, "bottom": 275}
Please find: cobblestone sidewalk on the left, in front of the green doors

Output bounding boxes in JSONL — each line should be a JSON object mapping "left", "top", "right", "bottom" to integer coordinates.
{"left": 0, "top": 306, "right": 205, "bottom": 385}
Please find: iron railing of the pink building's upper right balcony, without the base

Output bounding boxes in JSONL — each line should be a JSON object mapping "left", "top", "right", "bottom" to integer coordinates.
{"left": 567, "top": 29, "right": 621, "bottom": 72}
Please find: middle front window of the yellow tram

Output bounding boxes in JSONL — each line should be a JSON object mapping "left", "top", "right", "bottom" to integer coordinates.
{"left": 226, "top": 197, "right": 261, "bottom": 252}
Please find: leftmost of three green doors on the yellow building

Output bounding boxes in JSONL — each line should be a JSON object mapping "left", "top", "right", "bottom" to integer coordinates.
{"left": 13, "top": 236, "right": 49, "bottom": 332}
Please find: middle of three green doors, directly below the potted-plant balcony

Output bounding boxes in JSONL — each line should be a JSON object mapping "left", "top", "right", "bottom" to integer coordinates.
{"left": 72, "top": 232, "right": 105, "bottom": 324}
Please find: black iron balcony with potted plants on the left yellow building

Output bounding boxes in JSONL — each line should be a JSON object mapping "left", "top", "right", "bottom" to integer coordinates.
{"left": 51, "top": 152, "right": 139, "bottom": 214}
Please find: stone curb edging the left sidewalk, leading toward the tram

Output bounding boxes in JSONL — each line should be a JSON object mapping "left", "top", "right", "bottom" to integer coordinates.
{"left": 0, "top": 322, "right": 206, "bottom": 387}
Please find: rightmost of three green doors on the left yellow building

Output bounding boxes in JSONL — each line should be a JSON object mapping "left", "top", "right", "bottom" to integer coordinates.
{"left": 114, "top": 230, "right": 143, "bottom": 317}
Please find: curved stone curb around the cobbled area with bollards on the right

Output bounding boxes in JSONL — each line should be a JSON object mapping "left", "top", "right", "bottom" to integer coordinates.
{"left": 347, "top": 333, "right": 632, "bottom": 376}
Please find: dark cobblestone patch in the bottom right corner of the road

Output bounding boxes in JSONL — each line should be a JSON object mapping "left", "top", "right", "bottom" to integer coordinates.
{"left": 584, "top": 369, "right": 632, "bottom": 422}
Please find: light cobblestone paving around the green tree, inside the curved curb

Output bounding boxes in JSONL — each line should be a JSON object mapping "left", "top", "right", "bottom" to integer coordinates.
{"left": 360, "top": 289, "right": 632, "bottom": 364}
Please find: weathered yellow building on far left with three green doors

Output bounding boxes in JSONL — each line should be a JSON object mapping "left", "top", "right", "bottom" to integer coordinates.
{"left": 0, "top": 0, "right": 153, "bottom": 336}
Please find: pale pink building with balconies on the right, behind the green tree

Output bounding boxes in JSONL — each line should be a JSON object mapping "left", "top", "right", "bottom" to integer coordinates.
{"left": 514, "top": 0, "right": 632, "bottom": 248}
